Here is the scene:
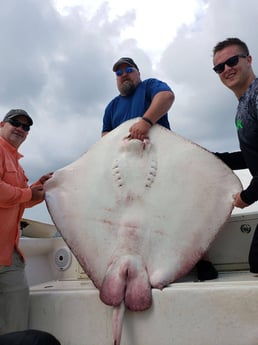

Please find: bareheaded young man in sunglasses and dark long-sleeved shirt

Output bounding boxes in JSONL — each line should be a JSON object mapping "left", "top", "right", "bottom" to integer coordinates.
{"left": 213, "top": 38, "right": 258, "bottom": 273}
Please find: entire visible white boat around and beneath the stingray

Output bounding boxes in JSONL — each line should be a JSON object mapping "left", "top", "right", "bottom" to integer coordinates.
{"left": 21, "top": 213, "right": 258, "bottom": 345}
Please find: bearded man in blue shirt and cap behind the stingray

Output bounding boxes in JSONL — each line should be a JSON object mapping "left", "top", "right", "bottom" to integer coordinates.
{"left": 102, "top": 57, "right": 175, "bottom": 140}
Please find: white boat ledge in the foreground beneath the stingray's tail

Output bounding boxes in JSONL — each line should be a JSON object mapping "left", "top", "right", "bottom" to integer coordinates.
{"left": 27, "top": 271, "right": 258, "bottom": 345}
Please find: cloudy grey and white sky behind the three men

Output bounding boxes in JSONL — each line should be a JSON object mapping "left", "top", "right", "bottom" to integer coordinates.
{"left": 0, "top": 0, "right": 258, "bottom": 221}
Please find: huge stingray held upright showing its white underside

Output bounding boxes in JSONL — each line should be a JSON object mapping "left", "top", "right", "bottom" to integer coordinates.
{"left": 45, "top": 119, "right": 242, "bottom": 345}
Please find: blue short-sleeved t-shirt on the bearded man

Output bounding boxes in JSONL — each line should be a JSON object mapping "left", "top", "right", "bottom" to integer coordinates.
{"left": 102, "top": 78, "right": 171, "bottom": 132}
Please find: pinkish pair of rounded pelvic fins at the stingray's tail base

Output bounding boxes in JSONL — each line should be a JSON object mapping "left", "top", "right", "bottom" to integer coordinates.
{"left": 100, "top": 255, "right": 151, "bottom": 311}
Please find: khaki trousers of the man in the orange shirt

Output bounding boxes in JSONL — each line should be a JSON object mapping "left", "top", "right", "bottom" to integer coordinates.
{"left": 0, "top": 252, "right": 29, "bottom": 334}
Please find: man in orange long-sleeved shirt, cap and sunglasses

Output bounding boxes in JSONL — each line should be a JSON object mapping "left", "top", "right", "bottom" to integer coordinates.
{"left": 0, "top": 109, "right": 52, "bottom": 334}
